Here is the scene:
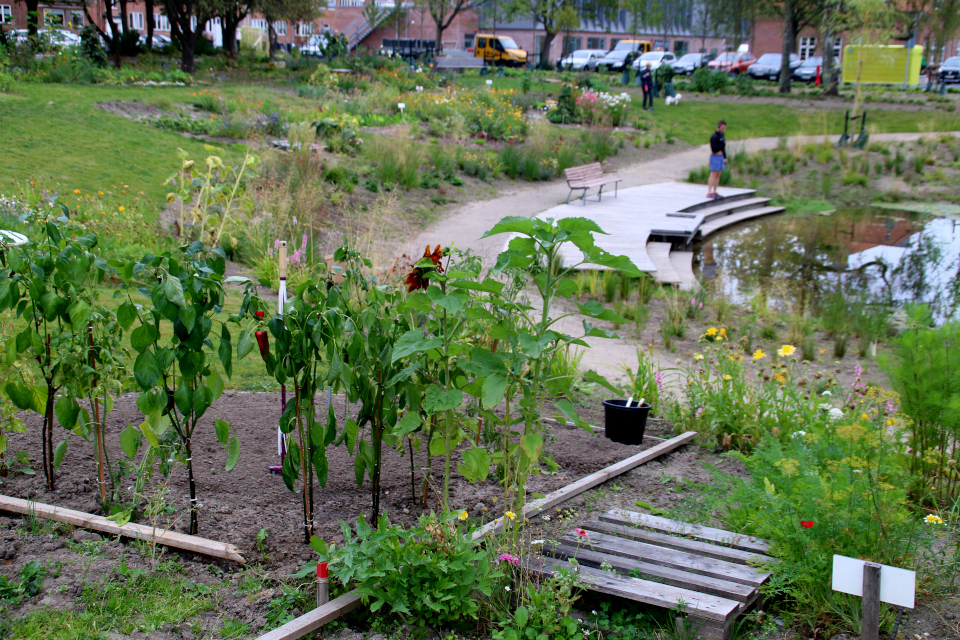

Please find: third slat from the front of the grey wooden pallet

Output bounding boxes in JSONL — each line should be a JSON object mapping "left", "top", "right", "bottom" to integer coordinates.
{"left": 560, "top": 529, "right": 770, "bottom": 587}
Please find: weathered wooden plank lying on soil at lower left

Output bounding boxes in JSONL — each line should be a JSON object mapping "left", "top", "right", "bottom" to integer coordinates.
{"left": 0, "top": 495, "right": 246, "bottom": 564}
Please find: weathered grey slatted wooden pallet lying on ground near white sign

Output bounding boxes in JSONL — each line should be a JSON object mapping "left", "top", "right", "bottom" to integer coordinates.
{"left": 525, "top": 510, "right": 777, "bottom": 640}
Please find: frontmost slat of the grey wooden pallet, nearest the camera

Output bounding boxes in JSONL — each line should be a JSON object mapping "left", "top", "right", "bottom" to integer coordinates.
{"left": 522, "top": 556, "right": 740, "bottom": 625}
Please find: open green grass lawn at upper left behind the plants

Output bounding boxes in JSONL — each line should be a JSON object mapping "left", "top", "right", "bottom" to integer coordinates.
{"left": 0, "top": 83, "right": 248, "bottom": 219}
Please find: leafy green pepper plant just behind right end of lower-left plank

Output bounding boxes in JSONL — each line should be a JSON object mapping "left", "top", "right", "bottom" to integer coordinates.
{"left": 117, "top": 241, "right": 253, "bottom": 534}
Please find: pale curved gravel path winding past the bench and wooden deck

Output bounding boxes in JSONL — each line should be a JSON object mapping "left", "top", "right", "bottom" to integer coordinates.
{"left": 398, "top": 132, "right": 960, "bottom": 377}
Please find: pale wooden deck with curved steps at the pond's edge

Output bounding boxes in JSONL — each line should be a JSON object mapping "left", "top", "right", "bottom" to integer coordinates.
{"left": 537, "top": 182, "right": 783, "bottom": 289}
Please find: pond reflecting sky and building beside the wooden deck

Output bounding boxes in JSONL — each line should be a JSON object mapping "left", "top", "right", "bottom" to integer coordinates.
{"left": 694, "top": 203, "right": 960, "bottom": 320}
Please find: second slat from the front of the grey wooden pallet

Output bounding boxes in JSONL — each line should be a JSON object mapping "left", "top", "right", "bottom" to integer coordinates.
{"left": 544, "top": 544, "right": 759, "bottom": 608}
